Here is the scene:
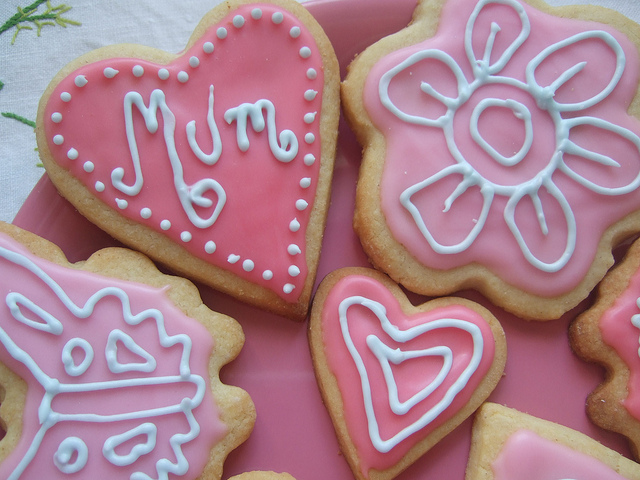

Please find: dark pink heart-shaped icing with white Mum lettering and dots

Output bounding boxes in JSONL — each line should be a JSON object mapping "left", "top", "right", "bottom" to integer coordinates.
{"left": 44, "top": 4, "right": 324, "bottom": 302}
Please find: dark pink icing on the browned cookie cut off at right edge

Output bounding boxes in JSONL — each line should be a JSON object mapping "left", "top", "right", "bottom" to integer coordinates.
{"left": 599, "top": 260, "right": 640, "bottom": 420}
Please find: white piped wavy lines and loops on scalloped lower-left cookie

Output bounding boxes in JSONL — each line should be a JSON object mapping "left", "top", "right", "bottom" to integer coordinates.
{"left": 0, "top": 242, "right": 207, "bottom": 480}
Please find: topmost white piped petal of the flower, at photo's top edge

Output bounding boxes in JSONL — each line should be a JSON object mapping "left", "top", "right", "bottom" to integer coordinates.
{"left": 464, "top": 0, "right": 531, "bottom": 77}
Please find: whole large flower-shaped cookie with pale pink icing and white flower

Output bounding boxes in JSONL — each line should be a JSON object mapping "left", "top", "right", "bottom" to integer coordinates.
{"left": 343, "top": 0, "right": 640, "bottom": 320}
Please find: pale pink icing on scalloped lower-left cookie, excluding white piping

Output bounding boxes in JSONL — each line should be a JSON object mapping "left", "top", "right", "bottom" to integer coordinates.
{"left": 0, "top": 231, "right": 226, "bottom": 479}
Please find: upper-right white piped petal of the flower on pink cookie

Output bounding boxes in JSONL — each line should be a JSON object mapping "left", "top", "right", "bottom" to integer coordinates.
{"left": 526, "top": 30, "right": 625, "bottom": 112}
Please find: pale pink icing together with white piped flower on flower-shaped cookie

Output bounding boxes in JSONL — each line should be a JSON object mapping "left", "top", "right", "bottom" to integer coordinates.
{"left": 365, "top": 0, "right": 640, "bottom": 294}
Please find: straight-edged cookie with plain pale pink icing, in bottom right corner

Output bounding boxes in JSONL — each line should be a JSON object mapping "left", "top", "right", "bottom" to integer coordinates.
{"left": 465, "top": 403, "right": 640, "bottom": 480}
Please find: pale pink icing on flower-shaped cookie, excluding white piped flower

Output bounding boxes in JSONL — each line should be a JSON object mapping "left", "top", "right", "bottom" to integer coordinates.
{"left": 364, "top": 0, "right": 640, "bottom": 296}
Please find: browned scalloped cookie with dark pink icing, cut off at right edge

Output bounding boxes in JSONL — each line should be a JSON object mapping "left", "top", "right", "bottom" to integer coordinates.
{"left": 570, "top": 240, "right": 640, "bottom": 459}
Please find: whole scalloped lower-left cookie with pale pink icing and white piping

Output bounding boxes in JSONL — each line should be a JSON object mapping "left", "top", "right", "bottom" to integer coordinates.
{"left": 0, "top": 224, "right": 255, "bottom": 480}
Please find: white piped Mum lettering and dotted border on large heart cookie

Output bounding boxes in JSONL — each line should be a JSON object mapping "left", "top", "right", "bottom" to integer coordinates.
{"left": 46, "top": 3, "right": 322, "bottom": 294}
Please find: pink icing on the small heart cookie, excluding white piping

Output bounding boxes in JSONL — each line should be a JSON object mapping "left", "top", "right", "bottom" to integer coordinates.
{"left": 322, "top": 275, "right": 495, "bottom": 476}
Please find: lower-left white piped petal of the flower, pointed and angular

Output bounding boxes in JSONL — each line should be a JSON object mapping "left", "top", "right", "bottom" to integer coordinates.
{"left": 400, "top": 165, "right": 494, "bottom": 254}
